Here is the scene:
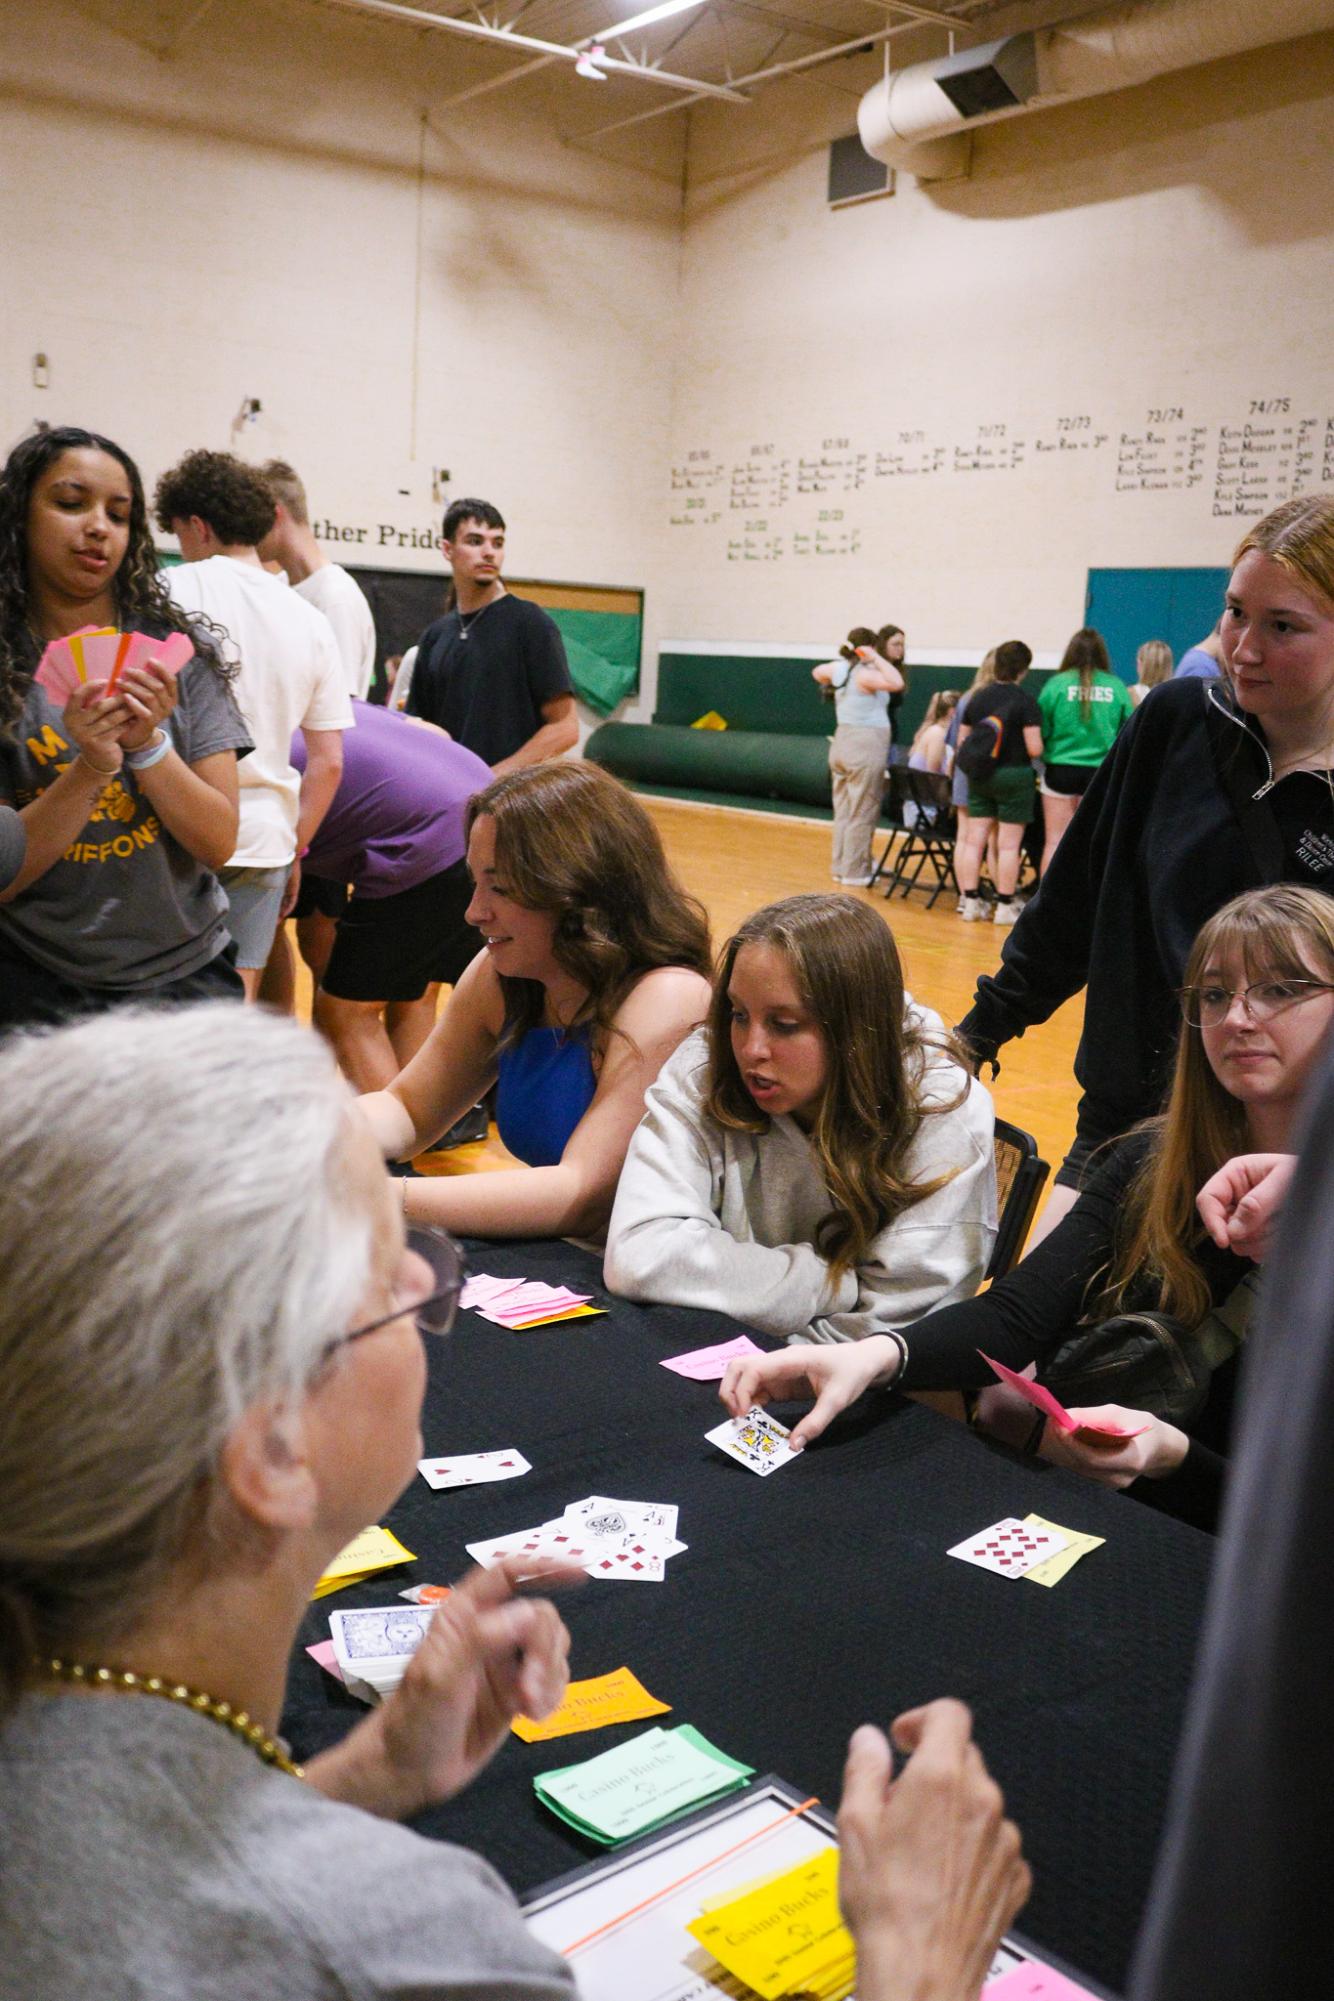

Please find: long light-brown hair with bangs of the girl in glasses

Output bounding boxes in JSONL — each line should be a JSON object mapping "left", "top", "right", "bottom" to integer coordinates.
{"left": 1090, "top": 882, "right": 1334, "bottom": 1325}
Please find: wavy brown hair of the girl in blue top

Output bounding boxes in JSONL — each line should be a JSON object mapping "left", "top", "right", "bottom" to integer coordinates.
{"left": 468, "top": 760, "right": 710, "bottom": 1045}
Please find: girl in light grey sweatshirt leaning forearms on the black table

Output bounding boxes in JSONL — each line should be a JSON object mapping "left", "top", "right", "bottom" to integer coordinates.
{"left": 606, "top": 896, "right": 996, "bottom": 1341}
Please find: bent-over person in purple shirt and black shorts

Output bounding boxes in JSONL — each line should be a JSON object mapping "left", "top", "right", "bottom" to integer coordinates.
{"left": 292, "top": 702, "right": 490, "bottom": 1091}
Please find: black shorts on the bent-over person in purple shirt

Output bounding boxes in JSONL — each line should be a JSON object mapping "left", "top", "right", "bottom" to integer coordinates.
{"left": 320, "top": 860, "right": 482, "bottom": 1016}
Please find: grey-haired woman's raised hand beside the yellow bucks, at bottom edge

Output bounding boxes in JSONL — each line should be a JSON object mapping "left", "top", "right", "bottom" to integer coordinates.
{"left": 838, "top": 1701, "right": 1032, "bottom": 2001}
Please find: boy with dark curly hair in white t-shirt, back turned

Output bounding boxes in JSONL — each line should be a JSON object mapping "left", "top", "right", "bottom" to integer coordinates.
{"left": 154, "top": 452, "right": 352, "bottom": 1001}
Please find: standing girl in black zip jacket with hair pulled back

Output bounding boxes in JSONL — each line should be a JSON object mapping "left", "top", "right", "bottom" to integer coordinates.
{"left": 960, "top": 496, "right": 1334, "bottom": 1229}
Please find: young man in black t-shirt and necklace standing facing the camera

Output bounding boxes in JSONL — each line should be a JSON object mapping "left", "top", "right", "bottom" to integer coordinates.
{"left": 406, "top": 500, "right": 578, "bottom": 778}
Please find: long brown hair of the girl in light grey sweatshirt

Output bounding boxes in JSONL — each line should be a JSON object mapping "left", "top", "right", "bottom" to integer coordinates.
{"left": 706, "top": 894, "right": 968, "bottom": 1277}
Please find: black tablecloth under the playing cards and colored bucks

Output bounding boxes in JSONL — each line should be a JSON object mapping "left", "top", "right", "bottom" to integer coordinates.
{"left": 284, "top": 1243, "right": 1214, "bottom": 1987}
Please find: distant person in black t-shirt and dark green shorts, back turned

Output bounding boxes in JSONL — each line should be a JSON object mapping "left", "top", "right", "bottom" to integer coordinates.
{"left": 954, "top": 638, "right": 1042, "bottom": 924}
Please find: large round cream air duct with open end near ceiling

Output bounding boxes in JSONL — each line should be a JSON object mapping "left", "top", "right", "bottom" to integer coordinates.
{"left": 858, "top": 0, "right": 1334, "bottom": 180}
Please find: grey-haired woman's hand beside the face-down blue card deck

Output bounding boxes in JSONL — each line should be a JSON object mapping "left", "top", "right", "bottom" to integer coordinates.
{"left": 316, "top": 1559, "right": 582, "bottom": 1819}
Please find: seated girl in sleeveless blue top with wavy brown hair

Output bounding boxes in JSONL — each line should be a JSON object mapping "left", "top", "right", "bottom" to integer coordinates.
{"left": 360, "top": 762, "right": 710, "bottom": 1237}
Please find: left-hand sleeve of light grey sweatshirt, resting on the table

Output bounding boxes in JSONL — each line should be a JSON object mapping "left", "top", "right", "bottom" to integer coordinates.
{"left": 602, "top": 1035, "right": 858, "bottom": 1335}
